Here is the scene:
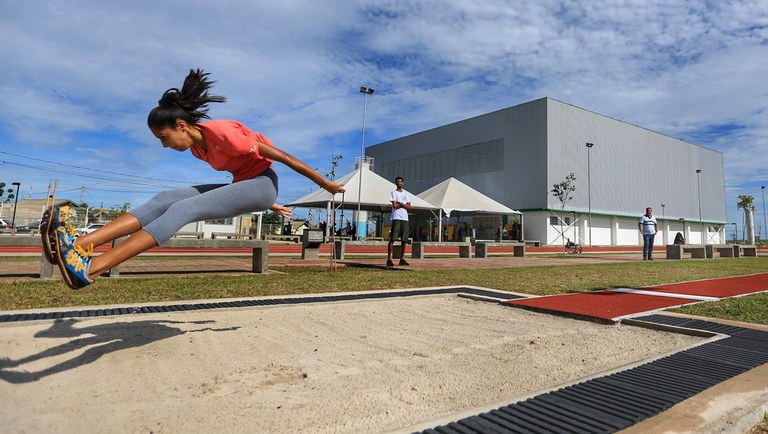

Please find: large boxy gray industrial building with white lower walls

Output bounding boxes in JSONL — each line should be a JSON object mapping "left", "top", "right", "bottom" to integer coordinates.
{"left": 366, "top": 98, "right": 727, "bottom": 245}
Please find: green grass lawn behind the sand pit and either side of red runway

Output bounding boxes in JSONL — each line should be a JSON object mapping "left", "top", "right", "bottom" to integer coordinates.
{"left": 0, "top": 257, "right": 768, "bottom": 324}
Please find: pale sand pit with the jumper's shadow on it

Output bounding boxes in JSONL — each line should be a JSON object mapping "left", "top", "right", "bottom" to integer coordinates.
{"left": 0, "top": 295, "right": 703, "bottom": 433}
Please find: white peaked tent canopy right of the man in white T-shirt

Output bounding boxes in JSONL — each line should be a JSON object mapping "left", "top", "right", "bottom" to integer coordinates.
{"left": 417, "top": 178, "right": 522, "bottom": 217}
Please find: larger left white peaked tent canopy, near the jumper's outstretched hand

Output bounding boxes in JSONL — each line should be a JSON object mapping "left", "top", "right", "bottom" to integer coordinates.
{"left": 286, "top": 166, "right": 436, "bottom": 212}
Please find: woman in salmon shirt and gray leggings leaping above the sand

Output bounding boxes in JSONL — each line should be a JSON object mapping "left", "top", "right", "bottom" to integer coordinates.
{"left": 53, "top": 69, "right": 344, "bottom": 289}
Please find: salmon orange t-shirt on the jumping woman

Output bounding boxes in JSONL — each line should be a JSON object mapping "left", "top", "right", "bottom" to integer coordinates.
{"left": 190, "top": 120, "right": 274, "bottom": 182}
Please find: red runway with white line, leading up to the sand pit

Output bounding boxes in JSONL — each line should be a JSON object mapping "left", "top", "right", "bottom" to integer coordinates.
{"left": 506, "top": 273, "right": 768, "bottom": 321}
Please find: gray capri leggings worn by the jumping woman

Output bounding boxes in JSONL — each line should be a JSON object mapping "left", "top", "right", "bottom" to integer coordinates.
{"left": 129, "top": 169, "right": 277, "bottom": 245}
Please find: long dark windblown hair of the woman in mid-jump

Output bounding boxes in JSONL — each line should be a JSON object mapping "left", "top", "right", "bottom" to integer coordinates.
{"left": 147, "top": 69, "right": 227, "bottom": 129}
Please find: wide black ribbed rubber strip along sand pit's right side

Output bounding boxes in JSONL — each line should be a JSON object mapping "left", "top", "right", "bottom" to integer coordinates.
{"left": 422, "top": 315, "right": 768, "bottom": 434}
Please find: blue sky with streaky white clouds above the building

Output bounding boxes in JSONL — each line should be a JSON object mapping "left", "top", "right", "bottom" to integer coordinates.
{"left": 0, "top": 0, "right": 768, "bottom": 237}
